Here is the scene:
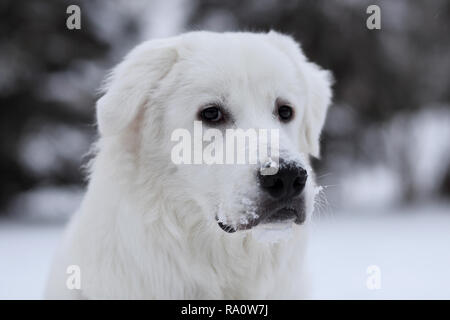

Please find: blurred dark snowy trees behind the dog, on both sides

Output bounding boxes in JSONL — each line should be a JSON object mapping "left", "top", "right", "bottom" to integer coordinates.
{"left": 0, "top": 0, "right": 450, "bottom": 219}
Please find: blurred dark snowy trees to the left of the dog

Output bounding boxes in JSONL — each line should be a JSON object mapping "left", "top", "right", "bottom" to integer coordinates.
{"left": 0, "top": 0, "right": 143, "bottom": 220}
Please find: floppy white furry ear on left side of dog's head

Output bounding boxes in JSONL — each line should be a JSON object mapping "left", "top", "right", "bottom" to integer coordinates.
{"left": 96, "top": 39, "right": 178, "bottom": 136}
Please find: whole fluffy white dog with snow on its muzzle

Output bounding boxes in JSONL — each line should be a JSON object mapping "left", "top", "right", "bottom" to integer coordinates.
{"left": 47, "top": 31, "right": 331, "bottom": 299}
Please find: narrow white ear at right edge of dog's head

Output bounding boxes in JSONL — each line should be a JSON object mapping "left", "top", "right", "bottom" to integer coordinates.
{"left": 268, "top": 31, "right": 333, "bottom": 158}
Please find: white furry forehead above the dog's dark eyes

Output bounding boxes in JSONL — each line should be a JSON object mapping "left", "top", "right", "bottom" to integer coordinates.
{"left": 179, "top": 34, "right": 300, "bottom": 102}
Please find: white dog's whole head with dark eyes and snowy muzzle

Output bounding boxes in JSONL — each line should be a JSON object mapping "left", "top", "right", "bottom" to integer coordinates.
{"left": 97, "top": 32, "right": 331, "bottom": 238}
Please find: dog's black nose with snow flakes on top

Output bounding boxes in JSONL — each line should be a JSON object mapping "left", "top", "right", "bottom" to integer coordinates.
{"left": 259, "top": 160, "right": 308, "bottom": 199}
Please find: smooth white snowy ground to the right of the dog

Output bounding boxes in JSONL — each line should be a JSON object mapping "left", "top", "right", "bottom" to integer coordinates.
{"left": 309, "top": 205, "right": 450, "bottom": 299}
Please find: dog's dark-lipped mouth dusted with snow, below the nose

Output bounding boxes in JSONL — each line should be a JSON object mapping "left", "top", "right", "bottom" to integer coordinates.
{"left": 216, "top": 206, "right": 306, "bottom": 233}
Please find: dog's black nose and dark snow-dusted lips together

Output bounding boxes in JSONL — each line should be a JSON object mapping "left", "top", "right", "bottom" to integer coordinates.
{"left": 218, "top": 159, "right": 308, "bottom": 233}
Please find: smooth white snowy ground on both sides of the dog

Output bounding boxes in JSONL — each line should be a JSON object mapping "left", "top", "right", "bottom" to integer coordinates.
{"left": 0, "top": 205, "right": 450, "bottom": 299}
